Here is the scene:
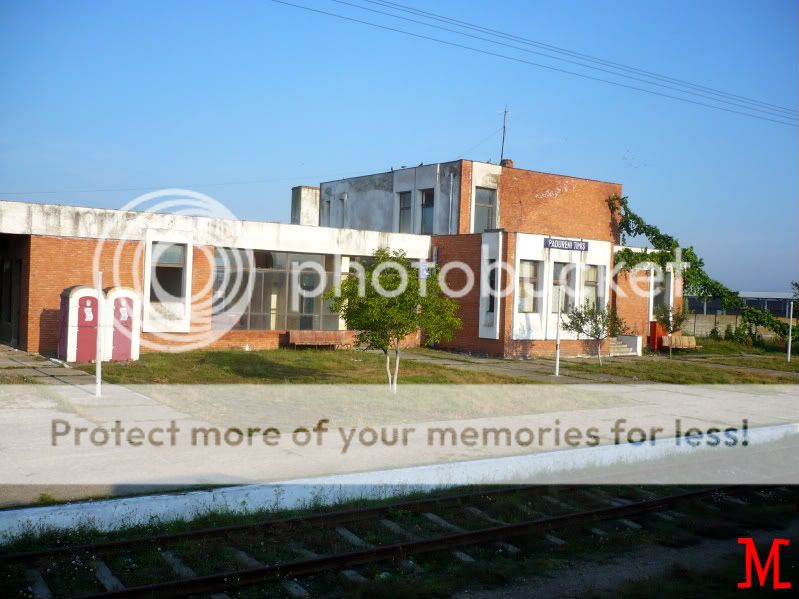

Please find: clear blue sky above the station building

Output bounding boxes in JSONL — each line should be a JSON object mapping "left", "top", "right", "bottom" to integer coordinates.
{"left": 0, "top": 0, "right": 799, "bottom": 290}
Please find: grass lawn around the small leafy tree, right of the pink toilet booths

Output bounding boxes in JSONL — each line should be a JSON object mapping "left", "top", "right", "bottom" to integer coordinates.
{"left": 81, "top": 349, "right": 529, "bottom": 384}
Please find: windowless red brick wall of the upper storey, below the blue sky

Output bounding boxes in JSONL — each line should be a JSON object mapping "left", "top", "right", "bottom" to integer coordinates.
{"left": 499, "top": 167, "right": 622, "bottom": 243}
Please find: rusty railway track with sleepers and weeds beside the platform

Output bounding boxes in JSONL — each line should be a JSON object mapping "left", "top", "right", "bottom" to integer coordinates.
{"left": 0, "top": 486, "right": 790, "bottom": 599}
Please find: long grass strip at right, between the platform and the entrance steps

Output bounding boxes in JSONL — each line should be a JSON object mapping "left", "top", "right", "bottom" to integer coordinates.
{"left": 561, "top": 356, "right": 799, "bottom": 384}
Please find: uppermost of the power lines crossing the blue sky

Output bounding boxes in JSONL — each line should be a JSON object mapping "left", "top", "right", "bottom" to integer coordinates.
{"left": 363, "top": 0, "right": 797, "bottom": 117}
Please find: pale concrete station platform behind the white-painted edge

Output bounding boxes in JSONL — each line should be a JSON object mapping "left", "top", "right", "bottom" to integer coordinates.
{"left": 0, "top": 347, "right": 799, "bottom": 505}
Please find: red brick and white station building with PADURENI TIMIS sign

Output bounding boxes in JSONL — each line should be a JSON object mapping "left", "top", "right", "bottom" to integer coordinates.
{"left": 0, "top": 160, "right": 681, "bottom": 357}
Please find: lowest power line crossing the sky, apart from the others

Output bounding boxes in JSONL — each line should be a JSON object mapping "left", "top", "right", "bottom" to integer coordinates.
{"left": 272, "top": 0, "right": 797, "bottom": 127}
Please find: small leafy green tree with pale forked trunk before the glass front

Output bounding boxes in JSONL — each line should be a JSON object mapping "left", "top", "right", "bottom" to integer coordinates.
{"left": 325, "top": 248, "right": 461, "bottom": 393}
